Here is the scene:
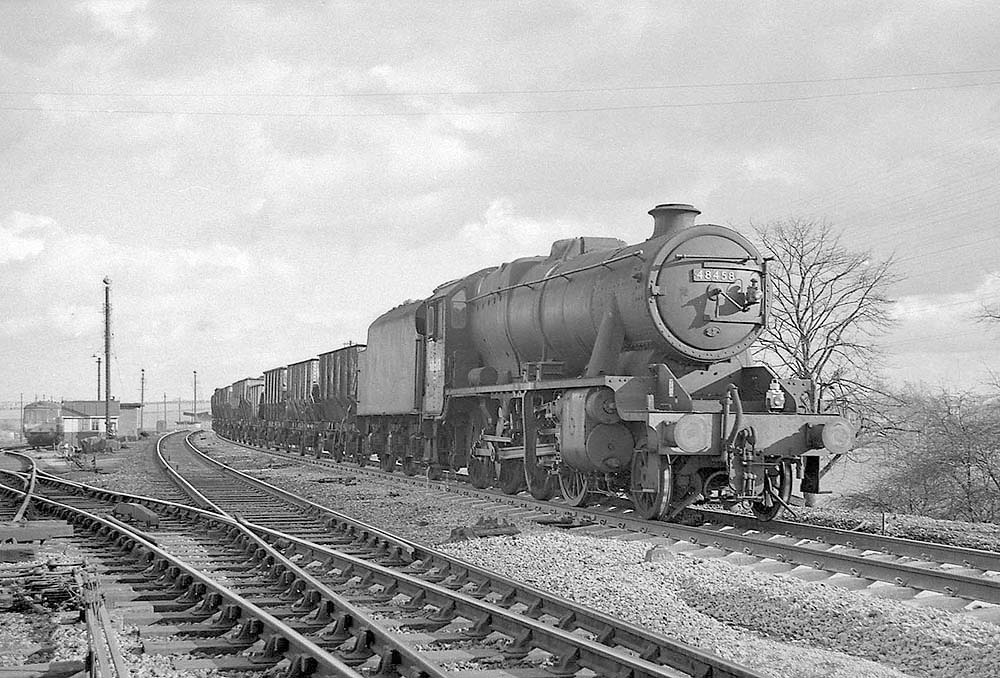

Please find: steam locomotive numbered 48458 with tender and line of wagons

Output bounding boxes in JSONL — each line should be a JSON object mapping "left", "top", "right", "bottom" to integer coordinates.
{"left": 212, "top": 204, "right": 854, "bottom": 520}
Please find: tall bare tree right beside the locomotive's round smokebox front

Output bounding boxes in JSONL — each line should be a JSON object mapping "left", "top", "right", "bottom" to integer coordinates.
{"left": 755, "top": 219, "right": 900, "bottom": 429}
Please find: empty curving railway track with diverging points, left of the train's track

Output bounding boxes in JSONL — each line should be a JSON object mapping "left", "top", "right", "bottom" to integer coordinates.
{"left": 3, "top": 436, "right": 760, "bottom": 678}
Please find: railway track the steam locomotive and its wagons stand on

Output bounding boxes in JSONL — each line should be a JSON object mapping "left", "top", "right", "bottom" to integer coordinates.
{"left": 209, "top": 438, "right": 1000, "bottom": 623}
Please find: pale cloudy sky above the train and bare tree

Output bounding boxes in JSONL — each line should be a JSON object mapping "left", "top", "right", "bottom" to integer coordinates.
{"left": 0, "top": 0, "right": 1000, "bottom": 404}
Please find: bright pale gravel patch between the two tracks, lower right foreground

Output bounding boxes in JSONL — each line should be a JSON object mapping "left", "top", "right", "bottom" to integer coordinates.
{"left": 442, "top": 533, "right": 1000, "bottom": 677}
